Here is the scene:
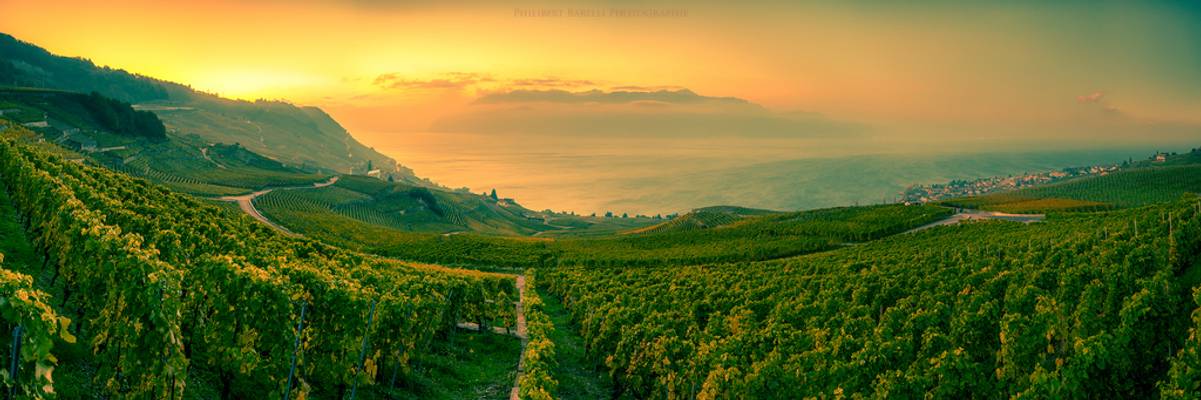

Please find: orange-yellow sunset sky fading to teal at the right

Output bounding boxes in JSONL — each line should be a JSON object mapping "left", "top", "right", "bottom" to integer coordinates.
{"left": 0, "top": 0, "right": 1201, "bottom": 142}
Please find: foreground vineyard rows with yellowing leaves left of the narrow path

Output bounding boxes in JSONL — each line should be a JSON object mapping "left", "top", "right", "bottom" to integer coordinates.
{"left": 0, "top": 130, "right": 515, "bottom": 399}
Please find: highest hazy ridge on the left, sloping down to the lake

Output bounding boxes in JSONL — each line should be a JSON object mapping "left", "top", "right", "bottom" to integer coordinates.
{"left": 0, "top": 34, "right": 422, "bottom": 183}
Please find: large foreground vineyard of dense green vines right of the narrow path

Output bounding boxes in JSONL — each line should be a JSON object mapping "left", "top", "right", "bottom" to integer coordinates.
{"left": 539, "top": 197, "right": 1201, "bottom": 399}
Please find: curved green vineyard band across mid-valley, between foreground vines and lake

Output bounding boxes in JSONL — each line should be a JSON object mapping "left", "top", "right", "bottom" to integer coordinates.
{"left": 256, "top": 193, "right": 949, "bottom": 268}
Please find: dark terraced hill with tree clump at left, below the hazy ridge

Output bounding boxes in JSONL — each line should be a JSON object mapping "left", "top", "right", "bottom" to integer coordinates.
{"left": 0, "top": 89, "right": 324, "bottom": 196}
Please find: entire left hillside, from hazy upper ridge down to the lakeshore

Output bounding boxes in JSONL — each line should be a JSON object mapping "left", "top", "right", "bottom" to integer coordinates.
{"left": 0, "top": 34, "right": 638, "bottom": 235}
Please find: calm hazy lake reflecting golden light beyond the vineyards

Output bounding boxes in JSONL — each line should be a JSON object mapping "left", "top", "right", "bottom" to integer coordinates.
{"left": 376, "top": 133, "right": 1153, "bottom": 214}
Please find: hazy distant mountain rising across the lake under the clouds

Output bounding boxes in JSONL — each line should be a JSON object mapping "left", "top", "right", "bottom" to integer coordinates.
{"left": 431, "top": 89, "right": 866, "bottom": 138}
